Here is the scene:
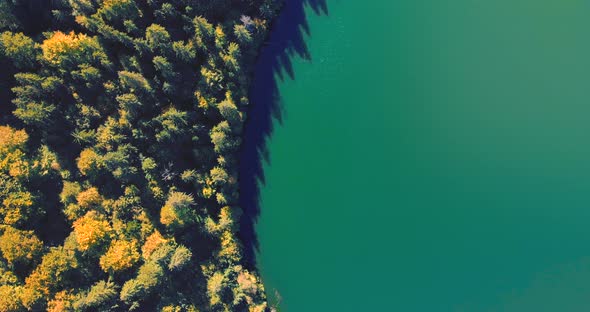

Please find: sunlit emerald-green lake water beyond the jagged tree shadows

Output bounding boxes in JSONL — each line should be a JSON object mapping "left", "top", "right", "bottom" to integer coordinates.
{"left": 256, "top": 0, "right": 590, "bottom": 312}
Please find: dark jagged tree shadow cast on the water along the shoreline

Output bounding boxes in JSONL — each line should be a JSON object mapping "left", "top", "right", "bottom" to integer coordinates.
{"left": 238, "top": 0, "right": 328, "bottom": 267}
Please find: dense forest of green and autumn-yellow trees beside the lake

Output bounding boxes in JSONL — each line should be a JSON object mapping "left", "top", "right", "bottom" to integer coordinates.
{"left": 0, "top": 0, "right": 280, "bottom": 312}
